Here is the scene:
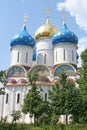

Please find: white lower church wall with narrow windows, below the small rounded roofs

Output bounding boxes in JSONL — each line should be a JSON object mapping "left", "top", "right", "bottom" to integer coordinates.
{"left": 0, "top": 86, "right": 50, "bottom": 123}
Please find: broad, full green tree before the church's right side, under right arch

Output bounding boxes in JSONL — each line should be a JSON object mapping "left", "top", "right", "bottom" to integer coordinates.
{"left": 49, "top": 72, "right": 81, "bottom": 124}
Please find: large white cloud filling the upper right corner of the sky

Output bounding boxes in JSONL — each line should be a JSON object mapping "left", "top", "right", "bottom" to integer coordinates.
{"left": 57, "top": 0, "right": 87, "bottom": 32}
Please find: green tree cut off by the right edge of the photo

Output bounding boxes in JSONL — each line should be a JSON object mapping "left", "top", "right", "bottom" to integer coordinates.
{"left": 77, "top": 49, "right": 87, "bottom": 123}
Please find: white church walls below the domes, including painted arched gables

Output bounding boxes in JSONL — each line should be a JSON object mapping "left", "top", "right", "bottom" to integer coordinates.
{"left": 0, "top": 16, "right": 77, "bottom": 123}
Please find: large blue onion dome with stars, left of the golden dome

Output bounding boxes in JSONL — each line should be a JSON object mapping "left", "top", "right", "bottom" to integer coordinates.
{"left": 10, "top": 24, "right": 35, "bottom": 48}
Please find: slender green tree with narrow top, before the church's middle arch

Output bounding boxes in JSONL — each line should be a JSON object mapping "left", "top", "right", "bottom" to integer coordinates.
{"left": 22, "top": 73, "right": 49, "bottom": 125}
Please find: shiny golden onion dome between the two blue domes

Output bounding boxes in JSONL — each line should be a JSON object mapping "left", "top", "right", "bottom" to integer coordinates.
{"left": 34, "top": 17, "right": 58, "bottom": 41}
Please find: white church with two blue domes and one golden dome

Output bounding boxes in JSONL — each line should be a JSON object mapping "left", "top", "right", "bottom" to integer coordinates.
{"left": 0, "top": 10, "right": 78, "bottom": 123}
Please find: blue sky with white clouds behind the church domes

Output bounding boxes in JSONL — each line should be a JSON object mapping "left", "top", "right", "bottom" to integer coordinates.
{"left": 0, "top": 0, "right": 87, "bottom": 70}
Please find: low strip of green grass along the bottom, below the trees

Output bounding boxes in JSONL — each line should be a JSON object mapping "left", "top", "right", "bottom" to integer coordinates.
{"left": 0, "top": 123, "right": 87, "bottom": 130}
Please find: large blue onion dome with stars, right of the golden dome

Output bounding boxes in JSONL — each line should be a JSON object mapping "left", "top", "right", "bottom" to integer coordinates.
{"left": 52, "top": 23, "right": 78, "bottom": 45}
